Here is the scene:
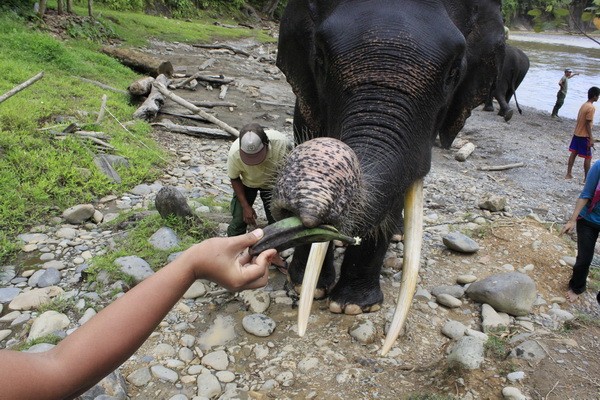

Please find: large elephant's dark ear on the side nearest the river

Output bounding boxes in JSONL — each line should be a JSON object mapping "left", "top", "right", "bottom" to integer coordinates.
{"left": 439, "top": 0, "right": 505, "bottom": 148}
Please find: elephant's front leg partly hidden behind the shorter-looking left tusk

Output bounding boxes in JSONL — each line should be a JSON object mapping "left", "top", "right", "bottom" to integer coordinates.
{"left": 288, "top": 243, "right": 335, "bottom": 300}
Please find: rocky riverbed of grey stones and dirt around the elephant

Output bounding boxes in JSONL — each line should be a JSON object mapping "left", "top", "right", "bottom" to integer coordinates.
{"left": 0, "top": 41, "right": 600, "bottom": 399}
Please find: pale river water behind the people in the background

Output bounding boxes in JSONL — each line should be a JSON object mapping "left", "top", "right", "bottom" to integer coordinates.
{"left": 509, "top": 31, "right": 600, "bottom": 124}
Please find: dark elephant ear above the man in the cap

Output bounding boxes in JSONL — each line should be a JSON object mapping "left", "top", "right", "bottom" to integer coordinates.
{"left": 277, "top": 0, "right": 320, "bottom": 135}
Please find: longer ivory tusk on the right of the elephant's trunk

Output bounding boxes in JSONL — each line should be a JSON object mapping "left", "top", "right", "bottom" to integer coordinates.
{"left": 381, "top": 179, "right": 423, "bottom": 356}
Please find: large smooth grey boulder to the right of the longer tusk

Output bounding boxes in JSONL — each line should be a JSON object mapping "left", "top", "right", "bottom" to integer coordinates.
{"left": 466, "top": 272, "right": 537, "bottom": 316}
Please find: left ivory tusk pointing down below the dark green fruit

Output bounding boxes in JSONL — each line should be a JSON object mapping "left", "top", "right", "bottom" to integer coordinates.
{"left": 298, "top": 242, "right": 329, "bottom": 336}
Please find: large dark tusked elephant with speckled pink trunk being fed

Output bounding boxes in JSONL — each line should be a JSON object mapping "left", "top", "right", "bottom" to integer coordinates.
{"left": 271, "top": 0, "right": 505, "bottom": 352}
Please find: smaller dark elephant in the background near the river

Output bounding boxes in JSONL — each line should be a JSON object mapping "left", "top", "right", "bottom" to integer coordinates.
{"left": 483, "top": 44, "right": 529, "bottom": 122}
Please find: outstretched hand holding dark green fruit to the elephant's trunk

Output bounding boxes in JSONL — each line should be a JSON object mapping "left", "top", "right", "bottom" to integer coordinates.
{"left": 182, "top": 229, "right": 277, "bottom": 291}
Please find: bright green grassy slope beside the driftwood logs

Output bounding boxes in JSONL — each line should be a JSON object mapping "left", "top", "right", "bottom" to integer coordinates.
{"left": 0, "top": 9, "right": 276, "bottom": 261}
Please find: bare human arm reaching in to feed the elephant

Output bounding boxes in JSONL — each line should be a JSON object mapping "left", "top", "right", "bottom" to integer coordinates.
{"left": 0, "top": 229, "right": 277, "bottom": 400}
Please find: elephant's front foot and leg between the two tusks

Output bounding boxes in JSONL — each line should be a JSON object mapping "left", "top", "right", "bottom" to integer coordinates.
{"left": 329, "top": 238, "right": 388, "bottom": 315}
